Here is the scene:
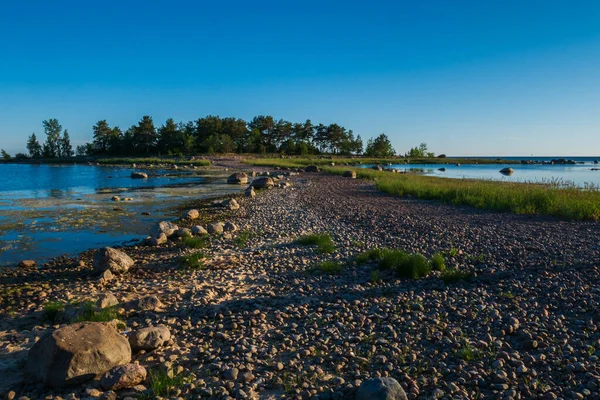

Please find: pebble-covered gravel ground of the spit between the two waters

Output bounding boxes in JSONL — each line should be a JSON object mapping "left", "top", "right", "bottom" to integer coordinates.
{"left": 0, "top": 169, "right": 600, "bottom": 399}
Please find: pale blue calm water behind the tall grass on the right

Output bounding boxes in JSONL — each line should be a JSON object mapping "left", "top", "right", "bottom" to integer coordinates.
{"left": 362, "top": 157, "right": 600, "bottom": 187}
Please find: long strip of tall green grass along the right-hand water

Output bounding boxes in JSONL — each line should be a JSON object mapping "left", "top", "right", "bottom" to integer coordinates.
{"left": 241, "top": 158, "right": 600, "bottom": 221}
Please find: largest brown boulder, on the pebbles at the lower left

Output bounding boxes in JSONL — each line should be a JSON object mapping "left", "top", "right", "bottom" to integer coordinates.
{"left": 26, "top": 322, "right": 131, "bottom": 388}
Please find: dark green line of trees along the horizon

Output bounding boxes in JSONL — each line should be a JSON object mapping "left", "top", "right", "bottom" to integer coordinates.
{"left": 16, "top": 115, "right": 433, "bottom": 158}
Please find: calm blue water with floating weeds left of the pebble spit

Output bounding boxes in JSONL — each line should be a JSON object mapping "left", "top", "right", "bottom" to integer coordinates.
{"left": 0, "top": 164, "right": 240, "bottom": 266}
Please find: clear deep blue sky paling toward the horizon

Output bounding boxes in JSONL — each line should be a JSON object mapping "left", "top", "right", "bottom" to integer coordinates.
{"left": 0, "top": 0, "right": 600, "bottom": 156}
